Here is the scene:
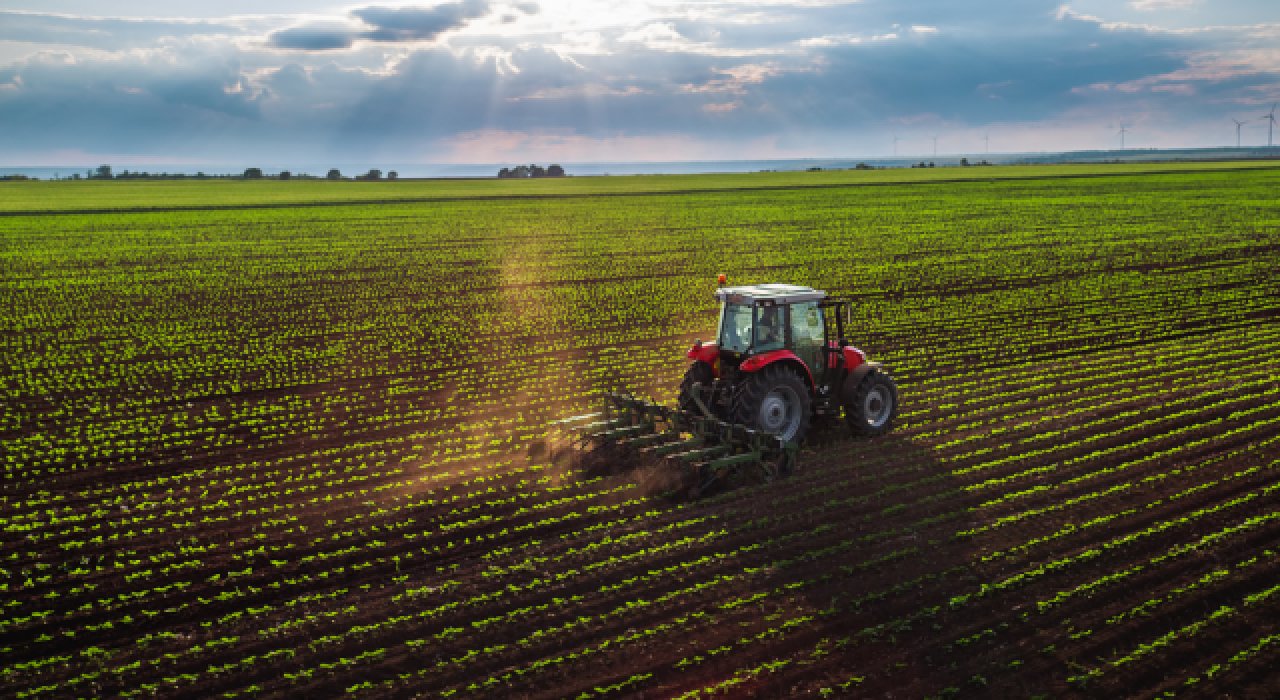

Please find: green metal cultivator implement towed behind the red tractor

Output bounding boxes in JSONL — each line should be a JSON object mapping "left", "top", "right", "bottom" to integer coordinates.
{"left": 557, "top": 384, "right": 800, "bottom": 495}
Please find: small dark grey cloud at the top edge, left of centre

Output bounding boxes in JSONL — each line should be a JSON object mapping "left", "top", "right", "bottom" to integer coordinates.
{"left": 268, "top": 0, "right": 538, "bottom": 51}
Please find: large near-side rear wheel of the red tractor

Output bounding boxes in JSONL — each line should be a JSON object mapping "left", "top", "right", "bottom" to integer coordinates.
{"left": 731, "top": 365, "right": 810, "bottom": 443}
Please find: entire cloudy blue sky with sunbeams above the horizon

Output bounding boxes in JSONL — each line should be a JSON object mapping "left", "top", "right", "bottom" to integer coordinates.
{"left": 0, "top": 0, "right": 1280, "bottom": 166}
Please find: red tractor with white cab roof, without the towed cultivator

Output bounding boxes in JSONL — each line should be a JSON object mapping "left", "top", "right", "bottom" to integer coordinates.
{"left": 678, "top": 278, "right": 897, "bottom": 443}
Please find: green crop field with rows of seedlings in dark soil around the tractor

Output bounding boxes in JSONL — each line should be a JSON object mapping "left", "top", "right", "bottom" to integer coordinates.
{"left": 0, "top": 165, "right": 1280, "bottom": 699}
